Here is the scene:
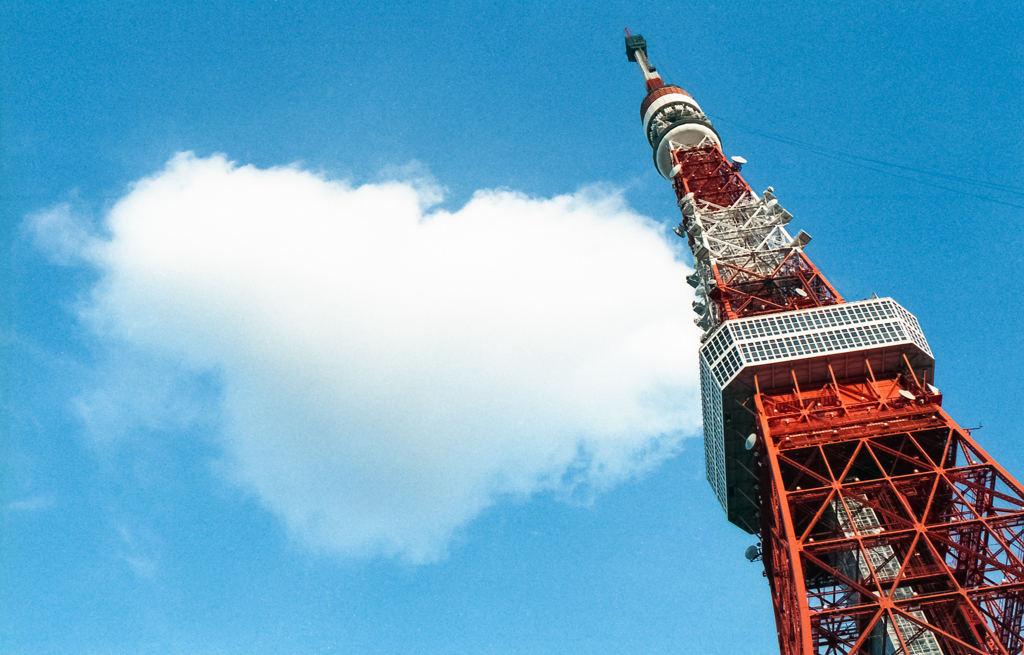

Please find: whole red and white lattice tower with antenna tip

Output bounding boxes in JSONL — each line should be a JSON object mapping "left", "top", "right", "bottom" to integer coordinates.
{"left": 626, "top": 31, "right": 1024, "bottom": 655}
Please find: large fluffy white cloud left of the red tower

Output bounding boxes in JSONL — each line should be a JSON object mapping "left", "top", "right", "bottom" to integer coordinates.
{"left": 36, "top": 155, "right": 699, "bottom": 562}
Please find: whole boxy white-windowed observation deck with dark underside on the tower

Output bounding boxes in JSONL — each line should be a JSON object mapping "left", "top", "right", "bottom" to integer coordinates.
{"left": 700, "top": 298, "right": 935, "bottom": 533}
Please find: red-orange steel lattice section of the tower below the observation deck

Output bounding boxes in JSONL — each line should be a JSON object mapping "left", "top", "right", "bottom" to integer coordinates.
{"left": 755, "top": 369, "right": 1024, "bottom": 655}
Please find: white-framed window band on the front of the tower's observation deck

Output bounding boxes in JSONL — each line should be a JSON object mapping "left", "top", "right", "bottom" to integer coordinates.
{"left": 700, "top": 298, "right": 932, "bottom": 389}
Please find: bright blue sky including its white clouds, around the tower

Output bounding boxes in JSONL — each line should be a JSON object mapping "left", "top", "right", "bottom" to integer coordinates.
{"left": 0, "top": 0, "right": 1024, "bottom": 655}
